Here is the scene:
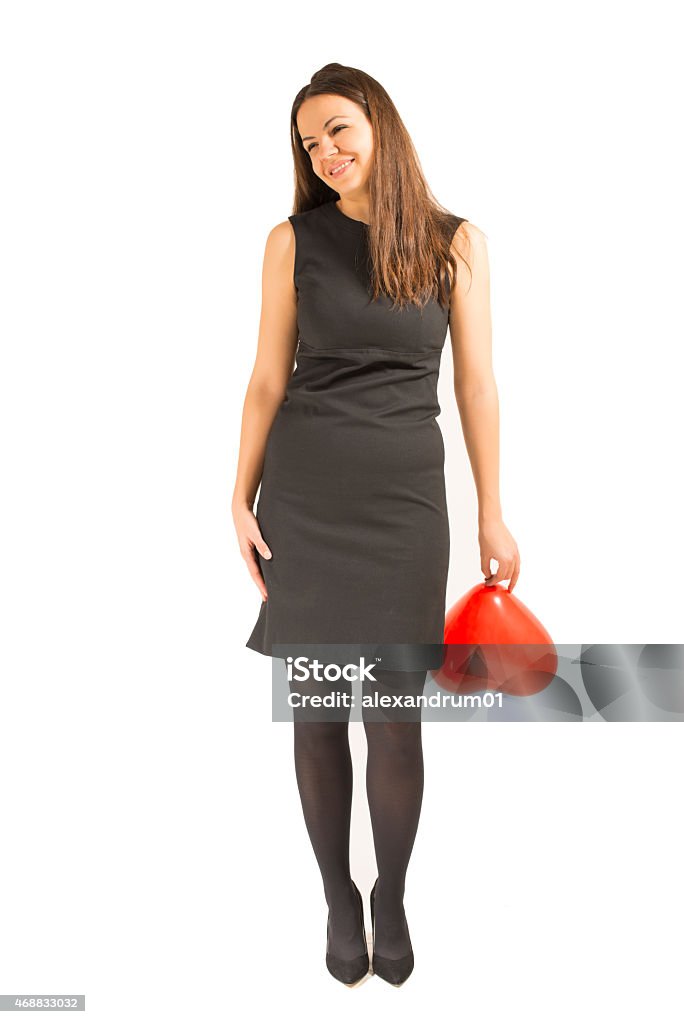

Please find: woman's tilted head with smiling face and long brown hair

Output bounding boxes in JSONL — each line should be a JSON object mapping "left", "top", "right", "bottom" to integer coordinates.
{"left": 292, "top": 74, "right": 467, "bottom": 307}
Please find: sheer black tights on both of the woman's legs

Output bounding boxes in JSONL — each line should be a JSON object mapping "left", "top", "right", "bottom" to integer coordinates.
{"left": 294, "top": 670, "right": 426, "bottom": 959}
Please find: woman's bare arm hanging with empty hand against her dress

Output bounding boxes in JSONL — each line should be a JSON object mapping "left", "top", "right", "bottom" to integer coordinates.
{"left": 231, "top": 220, "right": 297, "bottom": 600}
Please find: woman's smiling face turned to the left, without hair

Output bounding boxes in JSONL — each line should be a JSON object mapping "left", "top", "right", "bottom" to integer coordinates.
{"left": 297, "top": 94, "right": 373, "bottom": 198}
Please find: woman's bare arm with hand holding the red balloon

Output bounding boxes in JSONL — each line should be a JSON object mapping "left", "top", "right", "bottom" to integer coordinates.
{"left": 450, "top": 221, "right": 520, "bottom": 591}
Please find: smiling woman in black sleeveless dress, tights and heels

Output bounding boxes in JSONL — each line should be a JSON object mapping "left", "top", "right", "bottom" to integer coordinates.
{"left": 232, "top": 63, "right": 519, "bottom": 985}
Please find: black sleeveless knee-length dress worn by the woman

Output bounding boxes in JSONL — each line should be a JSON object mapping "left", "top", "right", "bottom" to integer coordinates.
{"left": 246, "top": 201, "right": 465, "bottom": 668}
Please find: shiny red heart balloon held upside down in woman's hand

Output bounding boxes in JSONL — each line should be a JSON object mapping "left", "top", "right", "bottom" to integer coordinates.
{"left": 431, "top": 583, "right": 558, "bottom": 696}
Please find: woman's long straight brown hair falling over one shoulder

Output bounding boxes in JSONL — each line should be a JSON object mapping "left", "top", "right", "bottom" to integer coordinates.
{"left": 291, "top": 63, "right": 470, "bottom": 307}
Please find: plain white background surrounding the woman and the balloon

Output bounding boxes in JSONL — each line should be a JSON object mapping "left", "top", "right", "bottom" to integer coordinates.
{"left": 0, "top": 0, "right": 684, "bottom": 1024}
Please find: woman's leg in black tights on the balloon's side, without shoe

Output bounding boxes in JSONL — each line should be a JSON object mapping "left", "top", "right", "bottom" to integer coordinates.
{"left": 364, "top": 670, "right": 426, "bottom": 958}
